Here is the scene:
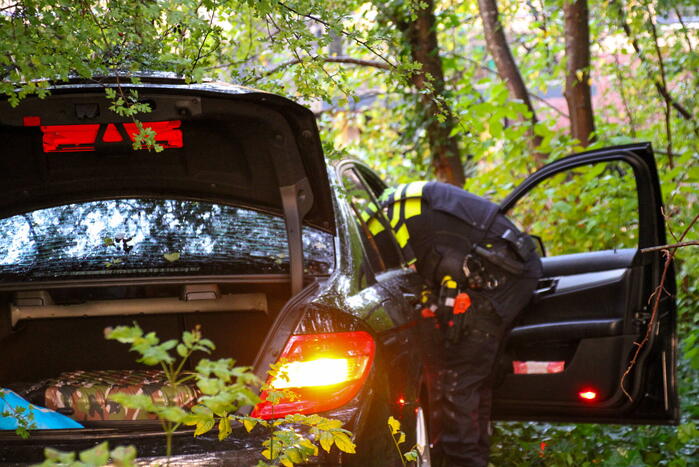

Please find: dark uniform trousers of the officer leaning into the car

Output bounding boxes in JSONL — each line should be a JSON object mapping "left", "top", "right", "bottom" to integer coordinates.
{"left": 420, "top": 213, "right": 541, "bottom": 466}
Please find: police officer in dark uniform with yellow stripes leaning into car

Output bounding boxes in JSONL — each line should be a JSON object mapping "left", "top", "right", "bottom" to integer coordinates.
{"left": 370, "top": 182, "right": 541, "bottom": 466}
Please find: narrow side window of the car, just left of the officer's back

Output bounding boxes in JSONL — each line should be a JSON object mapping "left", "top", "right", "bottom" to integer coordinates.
{"left": 342, "top": 169, "right": 401, "bottom": 273}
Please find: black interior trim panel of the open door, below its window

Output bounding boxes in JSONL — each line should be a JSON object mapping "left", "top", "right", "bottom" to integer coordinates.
{"left": 496, "top": 252, "right": 638, "bottom": 405}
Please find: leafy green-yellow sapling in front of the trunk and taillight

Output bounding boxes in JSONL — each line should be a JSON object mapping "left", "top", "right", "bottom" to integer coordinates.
{"left": 105, "top": 323, "right": 355, "bottom": 467}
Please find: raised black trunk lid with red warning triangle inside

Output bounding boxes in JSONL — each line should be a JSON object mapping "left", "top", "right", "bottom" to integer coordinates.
{"left": 0, "top": 80, "right": 335, "bottom": 232}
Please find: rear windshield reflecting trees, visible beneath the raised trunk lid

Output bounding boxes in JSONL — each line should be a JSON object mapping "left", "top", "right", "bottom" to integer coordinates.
{"left": 0, "top": 199, "right": 334, "bottom": 281}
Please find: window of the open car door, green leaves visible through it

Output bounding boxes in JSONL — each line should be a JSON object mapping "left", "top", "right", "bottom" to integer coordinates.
{"left": 508, "top": 161, "right": 639, "bottom": 256}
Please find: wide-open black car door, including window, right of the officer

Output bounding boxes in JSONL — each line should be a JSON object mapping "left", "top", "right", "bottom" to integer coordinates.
{"left": 493, "top": 143, "right": 679, "bottom": 423}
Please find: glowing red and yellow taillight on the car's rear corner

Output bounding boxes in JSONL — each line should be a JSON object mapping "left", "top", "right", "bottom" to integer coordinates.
{"left": 251, "top": 331, "right": 375, "bottom": 419}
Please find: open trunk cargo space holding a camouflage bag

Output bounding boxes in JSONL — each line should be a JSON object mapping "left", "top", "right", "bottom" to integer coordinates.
{"left": 0, "top": 281, "right": 289, "bottom": 428}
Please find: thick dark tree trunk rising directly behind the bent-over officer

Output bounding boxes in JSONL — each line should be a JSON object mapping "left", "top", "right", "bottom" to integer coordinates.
{"left": 392, "top": 0, "right": 465, "bottom": 187}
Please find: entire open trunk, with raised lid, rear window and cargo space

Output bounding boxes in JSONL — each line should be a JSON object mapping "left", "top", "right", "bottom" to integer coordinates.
{"left": 0, "top": 78, "right": 335, "bottom": 444}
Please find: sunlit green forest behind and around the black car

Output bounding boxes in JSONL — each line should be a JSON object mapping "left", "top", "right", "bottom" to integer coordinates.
{"left": 0, "top": 0, "right": 699, "bottom": 466}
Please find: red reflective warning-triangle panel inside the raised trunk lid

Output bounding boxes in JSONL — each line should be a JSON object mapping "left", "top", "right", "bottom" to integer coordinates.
{"left": 37, "top": 117, "right": 183, "bottom": 152}
